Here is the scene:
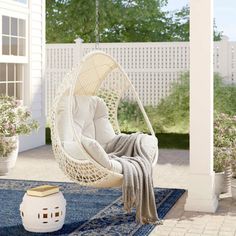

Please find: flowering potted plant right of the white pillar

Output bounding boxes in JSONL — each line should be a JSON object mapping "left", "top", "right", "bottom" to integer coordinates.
{"left": 214, "top": 113, "right": 236, "bottom": 197}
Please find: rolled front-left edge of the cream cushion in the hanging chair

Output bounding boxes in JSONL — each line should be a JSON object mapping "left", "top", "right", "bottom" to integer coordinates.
{"left": 81, "top": 136, "right": 122, "bottom": 174}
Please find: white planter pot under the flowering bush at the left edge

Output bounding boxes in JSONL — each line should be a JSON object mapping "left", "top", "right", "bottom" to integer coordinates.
{"left": 0, "top": 136, "right": 19, "bottom": 176}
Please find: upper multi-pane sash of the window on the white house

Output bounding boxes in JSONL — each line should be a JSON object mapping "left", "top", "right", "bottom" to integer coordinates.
{"left": 2, "top": 16, "right": 26, "bottom": 56}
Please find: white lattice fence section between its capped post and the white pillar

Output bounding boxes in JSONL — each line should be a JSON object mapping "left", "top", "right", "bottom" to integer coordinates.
{"left": 82, "top": 43, "right": 189, "bottom": 105}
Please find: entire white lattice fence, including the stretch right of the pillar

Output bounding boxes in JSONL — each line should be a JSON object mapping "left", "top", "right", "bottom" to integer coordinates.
{"left": 46, "top": 39, "right": 236, "bottom": 114}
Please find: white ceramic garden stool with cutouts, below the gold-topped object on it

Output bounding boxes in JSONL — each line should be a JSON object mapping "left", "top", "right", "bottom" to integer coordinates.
{"left": 20, "top": 192, "right": 66, "bottom": 233}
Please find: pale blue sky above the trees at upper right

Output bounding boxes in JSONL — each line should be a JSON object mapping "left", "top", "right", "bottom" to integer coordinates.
{"left": 165, "top": 0, "right": 236, "bottom": 41}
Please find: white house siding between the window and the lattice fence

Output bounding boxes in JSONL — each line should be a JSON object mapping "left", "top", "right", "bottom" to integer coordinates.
{"left": 20, "top": 0, "right": 45, "bottom": 151}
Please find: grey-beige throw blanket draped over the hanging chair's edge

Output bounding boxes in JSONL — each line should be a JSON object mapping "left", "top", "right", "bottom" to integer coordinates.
{"left": 105, "top": 133, "right": 161, "bottom": 224}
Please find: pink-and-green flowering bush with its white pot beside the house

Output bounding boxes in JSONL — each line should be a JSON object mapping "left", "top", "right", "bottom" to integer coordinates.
{"left": 0, "top": 95, "right": 39, "bottom": 175}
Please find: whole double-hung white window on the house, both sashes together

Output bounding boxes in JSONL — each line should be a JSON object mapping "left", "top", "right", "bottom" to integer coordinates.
{"left": 0, "top": 12, "right": 28, "bottom": 100}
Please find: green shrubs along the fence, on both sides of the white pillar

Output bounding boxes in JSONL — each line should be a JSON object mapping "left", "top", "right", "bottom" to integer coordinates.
{"left": 118, "top": 73, "right": 236, "bottom": 133}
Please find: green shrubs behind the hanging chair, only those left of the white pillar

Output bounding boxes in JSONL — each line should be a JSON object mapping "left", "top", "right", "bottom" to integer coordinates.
{"left": 118, "top": 74, "right": 189, "bottom": 133}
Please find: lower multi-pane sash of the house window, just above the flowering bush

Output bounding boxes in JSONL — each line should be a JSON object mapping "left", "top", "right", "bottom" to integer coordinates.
{"left": 0, "top": 63, "right": 25, "bottom": 100}
